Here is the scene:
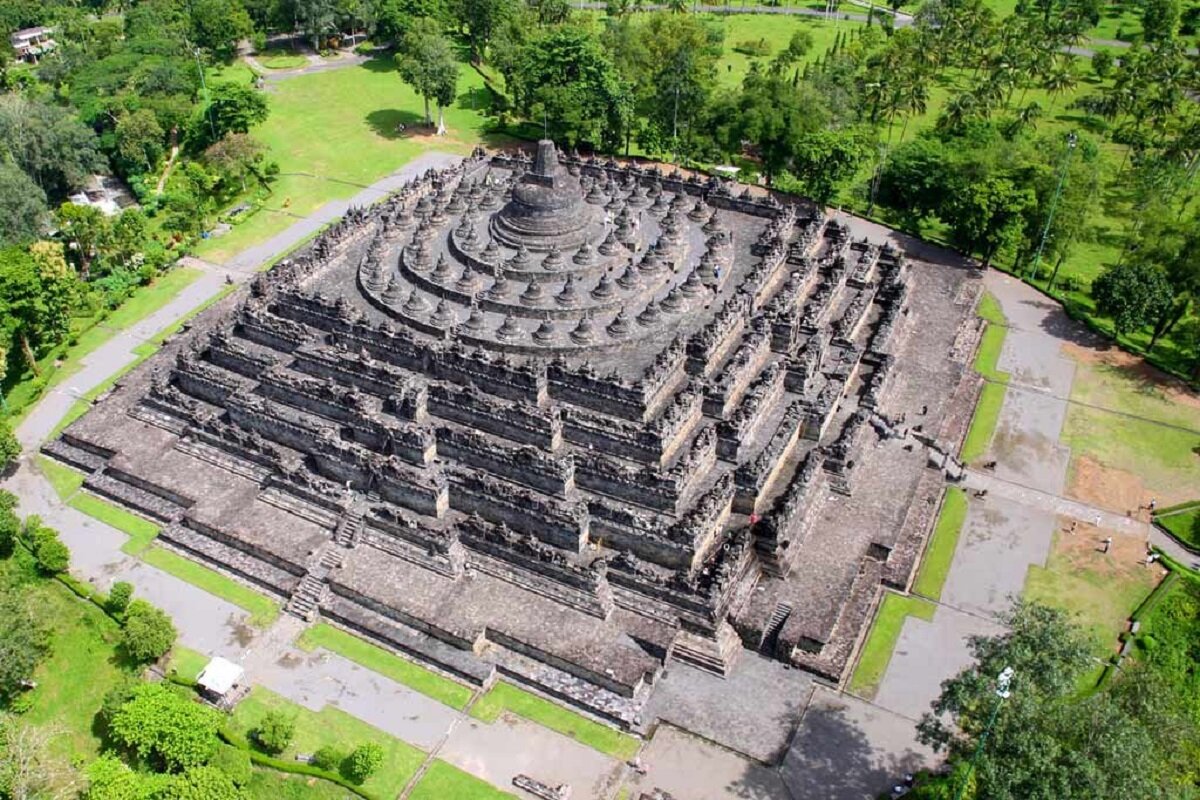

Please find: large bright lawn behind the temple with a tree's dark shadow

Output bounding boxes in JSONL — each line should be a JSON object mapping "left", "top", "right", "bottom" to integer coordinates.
{"left": 197, "top": 58, "right": 490, "bottom": 261}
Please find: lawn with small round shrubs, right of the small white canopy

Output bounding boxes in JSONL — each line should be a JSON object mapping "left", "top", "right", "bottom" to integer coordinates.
{"left": 233, "top": 687, "right": 427, "bottom": 798}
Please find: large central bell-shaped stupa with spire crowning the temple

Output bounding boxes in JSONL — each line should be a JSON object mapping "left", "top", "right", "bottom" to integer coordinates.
{"left": 492, "top": 139, "right": 604, "bottom": 252}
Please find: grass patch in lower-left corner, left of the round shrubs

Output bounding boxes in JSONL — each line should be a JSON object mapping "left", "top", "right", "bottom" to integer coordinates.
{"left": 0, "top": 552, "right": 133, "bottom": 782}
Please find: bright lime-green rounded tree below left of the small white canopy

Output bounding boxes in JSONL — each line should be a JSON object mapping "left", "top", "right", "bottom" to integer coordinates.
{"left": 108, "top": 681, "right": 221, "bottom": 772}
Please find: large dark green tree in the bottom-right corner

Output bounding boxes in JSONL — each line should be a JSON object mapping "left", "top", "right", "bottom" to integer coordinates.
{"left": 918, "top": 602, "right": 1170, "bottom": 800}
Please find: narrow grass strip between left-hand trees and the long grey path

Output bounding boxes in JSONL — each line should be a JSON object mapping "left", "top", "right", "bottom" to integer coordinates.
{"left": 5, "top": 267, "right": 202, "bottom": 427}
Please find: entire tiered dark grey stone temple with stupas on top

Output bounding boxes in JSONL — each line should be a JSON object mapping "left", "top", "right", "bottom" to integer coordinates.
{"left": 46, "top": 142, "right": 978, "bottom": 726}
